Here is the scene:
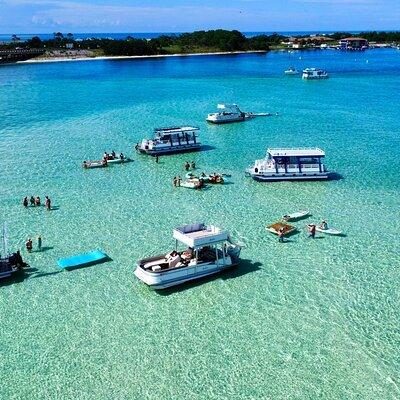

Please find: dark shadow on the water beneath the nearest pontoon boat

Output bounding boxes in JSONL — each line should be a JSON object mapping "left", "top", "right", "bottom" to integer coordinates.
{"left": 156, "top": 259, "right": 262, "bottom": 296}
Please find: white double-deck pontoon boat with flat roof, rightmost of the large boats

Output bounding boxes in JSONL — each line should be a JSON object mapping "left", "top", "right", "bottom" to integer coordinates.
{"left": 246, "top": 148, "right": 331, "bottom": 182}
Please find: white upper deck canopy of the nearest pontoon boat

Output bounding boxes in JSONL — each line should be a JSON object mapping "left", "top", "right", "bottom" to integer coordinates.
{"left": 173, "top": 223, "right": 229, "bottom": 249}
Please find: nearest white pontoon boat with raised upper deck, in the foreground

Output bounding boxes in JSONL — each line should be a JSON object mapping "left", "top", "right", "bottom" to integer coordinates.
{"left": 135, "top": 223, "right": 241, "bottom": 289}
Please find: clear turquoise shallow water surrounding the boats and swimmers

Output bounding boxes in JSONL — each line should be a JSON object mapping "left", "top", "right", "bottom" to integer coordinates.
{"left": 0, "top": 50, "right": 400, "bottom": 399}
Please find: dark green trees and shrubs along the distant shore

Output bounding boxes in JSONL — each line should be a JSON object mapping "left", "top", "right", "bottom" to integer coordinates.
{"left": 0, "top": 29, "right": 400, "bottom": 57}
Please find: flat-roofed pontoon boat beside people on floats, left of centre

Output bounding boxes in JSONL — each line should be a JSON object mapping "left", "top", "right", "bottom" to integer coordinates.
{"left": 135, "top": 126, "right": 201, "bottom": 156}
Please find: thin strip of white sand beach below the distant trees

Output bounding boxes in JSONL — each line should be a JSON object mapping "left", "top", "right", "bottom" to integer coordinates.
{"left": 16, "top": 50, "right": 268, "bottom": 64}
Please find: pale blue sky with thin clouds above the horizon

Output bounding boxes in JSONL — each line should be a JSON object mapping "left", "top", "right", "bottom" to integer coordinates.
{"left": 0, "top": 0, "right": 400, "bottom": 33}
